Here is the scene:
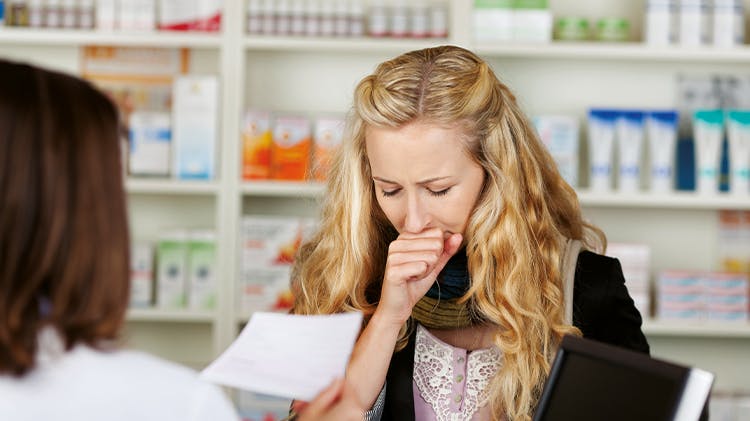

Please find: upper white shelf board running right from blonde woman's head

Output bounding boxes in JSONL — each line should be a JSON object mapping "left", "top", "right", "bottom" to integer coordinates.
{"left": 474, "top": 41, "right": 750, "bottom": 63}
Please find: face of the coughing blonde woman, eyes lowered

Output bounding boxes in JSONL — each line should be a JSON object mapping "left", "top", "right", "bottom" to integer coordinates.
{"left": 365, "top": 122, "right": 484, "bottom": 234}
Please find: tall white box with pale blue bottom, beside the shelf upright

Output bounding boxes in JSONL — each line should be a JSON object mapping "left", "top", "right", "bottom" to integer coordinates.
{"left": 172, "top": 76, "right": 219, "bottom": 180}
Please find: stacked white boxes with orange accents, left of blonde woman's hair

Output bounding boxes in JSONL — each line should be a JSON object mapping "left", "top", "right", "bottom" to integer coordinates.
{"left": 239, "top": 216, "right": 314, "bottom": 315}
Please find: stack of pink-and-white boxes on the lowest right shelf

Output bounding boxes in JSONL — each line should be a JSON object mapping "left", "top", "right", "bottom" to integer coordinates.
{"left": 656, "top": 271, "right": 748, "bottom": 322}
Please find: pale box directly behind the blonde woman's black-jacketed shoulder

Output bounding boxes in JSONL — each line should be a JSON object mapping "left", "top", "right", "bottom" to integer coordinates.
{"left": 607, "top": 243, "right": 651, "bottom": 318}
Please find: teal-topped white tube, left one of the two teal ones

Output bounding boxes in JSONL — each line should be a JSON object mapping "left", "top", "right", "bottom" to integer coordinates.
{"left": 693, "top": 110, "right": 724, "bottom": 194}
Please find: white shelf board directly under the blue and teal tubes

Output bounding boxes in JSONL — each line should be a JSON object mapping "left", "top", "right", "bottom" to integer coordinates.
{"left": 578, "top": 190, "right": 750, "bottom": 210}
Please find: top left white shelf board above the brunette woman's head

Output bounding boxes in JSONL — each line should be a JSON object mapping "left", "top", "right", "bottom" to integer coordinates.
{"left": 0, "top": 27, "right": 221, "bottom": 49}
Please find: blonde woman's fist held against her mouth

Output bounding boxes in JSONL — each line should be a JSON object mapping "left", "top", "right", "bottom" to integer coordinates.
{"left": 377, "top": 228, "right": 463, "bottom": 326}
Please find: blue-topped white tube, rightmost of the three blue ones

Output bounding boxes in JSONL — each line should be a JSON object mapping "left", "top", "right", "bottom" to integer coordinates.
{"left": 645, "top": 110, "right": 678, "bottom": 193}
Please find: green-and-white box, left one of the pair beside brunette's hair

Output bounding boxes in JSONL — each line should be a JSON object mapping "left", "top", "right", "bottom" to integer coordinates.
{"left": 156, "top": 231, "right": 188, "bottom": 310}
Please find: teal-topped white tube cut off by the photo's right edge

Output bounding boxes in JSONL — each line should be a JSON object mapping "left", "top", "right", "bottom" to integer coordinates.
{"left": 727, "top": 110, "right": 750, "bottom": 195}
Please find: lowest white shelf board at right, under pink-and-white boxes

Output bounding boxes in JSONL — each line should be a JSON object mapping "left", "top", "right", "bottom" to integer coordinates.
{"left": 643, "top": 320, "right": 750, "bottom": 339}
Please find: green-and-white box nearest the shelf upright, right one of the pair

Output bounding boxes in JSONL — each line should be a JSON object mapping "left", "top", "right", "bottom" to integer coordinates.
{"left": 187, "top": 231, "right": 216, "bottom": 311}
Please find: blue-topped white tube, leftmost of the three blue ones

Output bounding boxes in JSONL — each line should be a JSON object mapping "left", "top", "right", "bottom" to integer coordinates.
{"left": 588, "top": 109, "right": 619, "bottom": 191}
